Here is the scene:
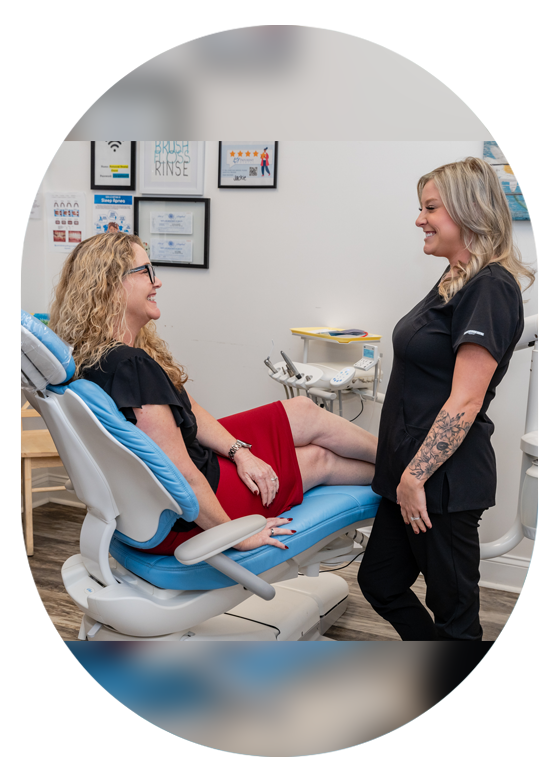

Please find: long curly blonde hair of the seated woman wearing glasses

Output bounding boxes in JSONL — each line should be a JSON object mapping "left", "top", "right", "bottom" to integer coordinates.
{"left": 49, "top": 233, "right": 188, "bottom": 390}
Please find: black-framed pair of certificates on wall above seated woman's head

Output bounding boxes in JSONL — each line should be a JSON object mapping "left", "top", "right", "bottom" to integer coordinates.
{"left": 134, "top": 196, "right": 210, "bottom": 269}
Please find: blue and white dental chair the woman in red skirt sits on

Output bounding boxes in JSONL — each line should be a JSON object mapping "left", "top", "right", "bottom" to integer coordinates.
{"left": 21, "top": 310, "right": 380, "bottom": 641}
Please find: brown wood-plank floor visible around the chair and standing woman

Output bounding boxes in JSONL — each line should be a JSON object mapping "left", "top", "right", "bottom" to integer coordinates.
{"left": 20, "top": 503, "right": 518, "bottom": 641}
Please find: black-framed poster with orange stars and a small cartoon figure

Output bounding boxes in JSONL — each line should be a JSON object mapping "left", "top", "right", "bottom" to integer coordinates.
{"left": 217, "top": 141, "right": 278, "bottom": 188}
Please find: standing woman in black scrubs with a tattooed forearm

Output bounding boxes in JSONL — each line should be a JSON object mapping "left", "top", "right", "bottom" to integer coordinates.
{"left": 358, "top": 157, "right": 535, "bottom": 641}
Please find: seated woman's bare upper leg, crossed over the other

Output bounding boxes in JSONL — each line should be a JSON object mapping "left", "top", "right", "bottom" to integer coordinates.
{"left": 282, "top": 396, "right": 377, "bottom": 464}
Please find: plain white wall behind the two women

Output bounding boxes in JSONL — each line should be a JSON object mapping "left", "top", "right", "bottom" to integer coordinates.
{"left": 21, "top": 139, "right": 537, "bottom": 580}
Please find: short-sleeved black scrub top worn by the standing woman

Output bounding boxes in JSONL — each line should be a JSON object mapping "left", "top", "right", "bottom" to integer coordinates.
{"left": 372, "top": 263, "right": 524, "bottom": 513}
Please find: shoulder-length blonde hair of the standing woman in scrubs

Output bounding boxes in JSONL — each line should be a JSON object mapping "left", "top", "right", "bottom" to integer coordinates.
{"left": 417, "top": 157, "right": 536, "bottom": 302}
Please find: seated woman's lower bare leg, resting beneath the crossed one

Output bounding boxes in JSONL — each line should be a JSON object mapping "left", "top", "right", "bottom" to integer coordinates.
{"left": 295, "top": 445, "right": 375, "bottom": 492}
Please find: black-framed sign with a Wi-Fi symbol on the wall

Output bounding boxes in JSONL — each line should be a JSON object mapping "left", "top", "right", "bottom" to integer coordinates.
{"left": 91, "top": 141, "right": 136, "bottom": 190}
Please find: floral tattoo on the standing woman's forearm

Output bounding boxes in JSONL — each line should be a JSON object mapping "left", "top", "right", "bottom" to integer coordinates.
{"left": 408, "top": 409, "right": 474, "bottom": 481}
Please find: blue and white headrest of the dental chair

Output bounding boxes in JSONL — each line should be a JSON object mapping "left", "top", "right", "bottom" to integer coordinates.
{"left": 21, "top": 310, "right": 76, "bottom": 392}
